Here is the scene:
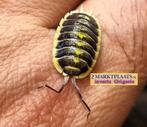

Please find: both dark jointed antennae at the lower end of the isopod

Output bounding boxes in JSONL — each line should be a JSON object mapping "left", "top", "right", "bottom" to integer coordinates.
{"left": 45, "top": 76, "right": 91, "bottom": 119}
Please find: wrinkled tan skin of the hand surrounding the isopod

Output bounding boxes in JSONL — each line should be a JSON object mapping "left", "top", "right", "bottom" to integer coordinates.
{"left": 0, "top": 0, "right": 147, "bottom": 127}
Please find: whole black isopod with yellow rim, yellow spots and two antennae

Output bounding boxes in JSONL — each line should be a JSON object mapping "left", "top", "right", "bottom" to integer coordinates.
{"left": 46, "top": 11, "right": 101, "bottom": 118}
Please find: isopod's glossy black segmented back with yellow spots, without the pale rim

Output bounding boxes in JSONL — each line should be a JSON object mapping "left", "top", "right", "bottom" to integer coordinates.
{"left": 55, "top": 13, "right": 98, "bottom": 76}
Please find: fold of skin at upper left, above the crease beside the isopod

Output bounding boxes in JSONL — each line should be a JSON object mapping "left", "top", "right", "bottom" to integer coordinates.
{"left": 0, "top": 0, "right": 82, "bottom": 27}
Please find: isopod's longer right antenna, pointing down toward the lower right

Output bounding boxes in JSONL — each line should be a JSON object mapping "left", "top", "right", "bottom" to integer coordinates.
{"left": 71, "top": 78, "right": 91, "bottom": 119}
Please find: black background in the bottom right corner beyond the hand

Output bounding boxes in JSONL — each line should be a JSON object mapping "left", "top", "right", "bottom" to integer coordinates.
{"left": 122, "top": 86, "right": 147, "bottom": 127}
